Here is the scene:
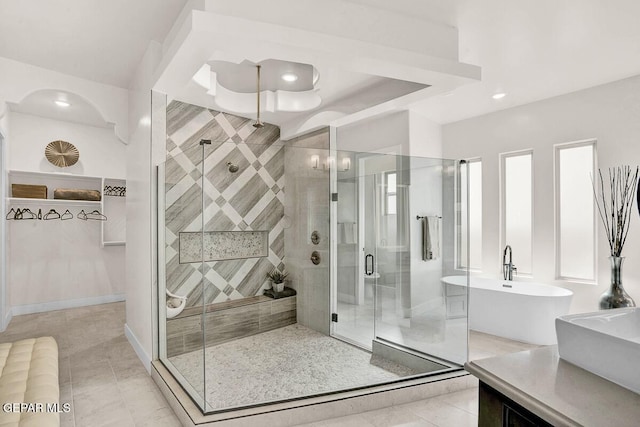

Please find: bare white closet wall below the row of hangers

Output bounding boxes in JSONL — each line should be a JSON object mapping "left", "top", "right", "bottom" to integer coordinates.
{"left": 7, "top": 221, "right": 124, "bottom": 315}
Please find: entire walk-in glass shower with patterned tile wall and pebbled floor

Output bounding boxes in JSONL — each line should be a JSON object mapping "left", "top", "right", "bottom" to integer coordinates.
{"left": 154, "top": 101, "right": 467, "bottom": 412}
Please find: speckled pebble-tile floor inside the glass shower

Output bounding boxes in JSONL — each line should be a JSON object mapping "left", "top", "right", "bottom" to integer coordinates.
{"left": 169, "top": 324, "right": 436, "bottom": 410}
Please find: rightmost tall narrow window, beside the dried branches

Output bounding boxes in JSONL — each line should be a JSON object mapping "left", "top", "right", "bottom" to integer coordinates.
{"left": 554, "top": 140, "right": 596, "bottom": 282}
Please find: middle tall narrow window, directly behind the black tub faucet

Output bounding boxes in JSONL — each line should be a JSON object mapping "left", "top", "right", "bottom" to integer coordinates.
{"left": 500, "top": 150, "right": 533, "bottom": 275}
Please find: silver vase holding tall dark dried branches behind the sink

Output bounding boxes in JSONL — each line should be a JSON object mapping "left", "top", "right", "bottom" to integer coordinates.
{"left": 593, "top": 166, "right": 640, "bottom": 310}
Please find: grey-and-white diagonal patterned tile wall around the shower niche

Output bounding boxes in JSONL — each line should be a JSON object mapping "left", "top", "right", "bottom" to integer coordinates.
{"left": 165, "top": 101, "right": 285, "bottom": 307}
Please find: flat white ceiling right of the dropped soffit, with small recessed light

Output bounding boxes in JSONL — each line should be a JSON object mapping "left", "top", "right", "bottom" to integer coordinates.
{"left": 404, "top": 0, "right": 640, "bottom": 123}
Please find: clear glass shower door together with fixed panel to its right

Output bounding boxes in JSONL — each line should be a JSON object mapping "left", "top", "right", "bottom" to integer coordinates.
{"left": 332, "top": 151, "right": 467, "bottom": 365}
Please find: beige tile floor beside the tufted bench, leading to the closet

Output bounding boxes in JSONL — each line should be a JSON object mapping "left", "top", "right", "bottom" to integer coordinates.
{"left": 0, "top": 303, "right": 180, "bottom": 427}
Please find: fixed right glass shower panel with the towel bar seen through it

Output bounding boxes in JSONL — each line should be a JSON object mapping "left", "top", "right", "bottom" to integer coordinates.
{"left": 374, "top": 156, "right": 467, "bottom": 364}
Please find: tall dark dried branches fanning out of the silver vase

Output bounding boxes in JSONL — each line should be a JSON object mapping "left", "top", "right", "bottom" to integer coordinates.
{"left": 591, "top": 166, "right": 640, "bottom": 256}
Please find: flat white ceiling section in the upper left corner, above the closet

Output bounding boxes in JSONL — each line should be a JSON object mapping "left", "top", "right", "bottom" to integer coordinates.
{"left": 0, "top": 0, "right": 186, "bottom": 88}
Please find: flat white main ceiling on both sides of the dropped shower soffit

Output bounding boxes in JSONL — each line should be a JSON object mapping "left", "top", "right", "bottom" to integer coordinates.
{"left": 0, "top": 0, "right": 640, "bottom": 123}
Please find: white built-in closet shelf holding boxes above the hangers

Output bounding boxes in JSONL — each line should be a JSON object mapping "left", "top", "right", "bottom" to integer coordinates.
{"left": 5, "top": 170, "right": 127, "bottom": 247}
